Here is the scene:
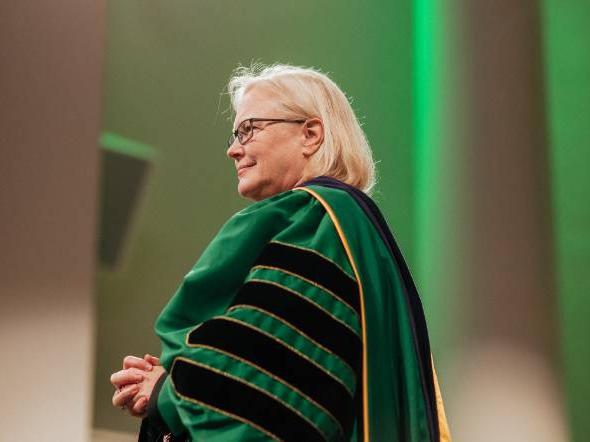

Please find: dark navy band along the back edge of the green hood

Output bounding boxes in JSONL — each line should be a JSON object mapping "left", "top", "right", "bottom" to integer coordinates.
{"left": 303, "top": 176, "right": 440, "bottom": 441}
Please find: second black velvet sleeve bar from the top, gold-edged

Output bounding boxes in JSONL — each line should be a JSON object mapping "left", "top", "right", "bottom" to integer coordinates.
{"left": 232, "top": 281, "right": 361, "bottom": 372}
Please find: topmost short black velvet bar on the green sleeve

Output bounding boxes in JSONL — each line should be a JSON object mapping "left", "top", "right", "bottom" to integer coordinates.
{"left": 255, "top": 242, "right": 360, "bottom": 314}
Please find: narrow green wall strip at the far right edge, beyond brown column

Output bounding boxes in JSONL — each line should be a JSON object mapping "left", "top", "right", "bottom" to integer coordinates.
{"left": 543, "top": 0, "right": 590, "bottom": 442}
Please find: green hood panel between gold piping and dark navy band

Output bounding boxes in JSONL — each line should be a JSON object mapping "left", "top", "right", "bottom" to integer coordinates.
{"left": 311, "top": 186, "right": 430, "bottom": 442}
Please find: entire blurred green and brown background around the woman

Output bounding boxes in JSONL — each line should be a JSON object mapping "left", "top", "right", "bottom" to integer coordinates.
{"left": 0, "top": 0, "right": 590, "bottom": 442}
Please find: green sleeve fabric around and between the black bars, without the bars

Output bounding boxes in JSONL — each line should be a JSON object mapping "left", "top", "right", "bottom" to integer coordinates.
{"left": 156, "top": 191, "right": 360, "bottom": 440}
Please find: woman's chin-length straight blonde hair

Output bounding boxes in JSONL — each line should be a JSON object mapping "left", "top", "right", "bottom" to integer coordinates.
{"left": 228, "top": 63, "right": 375, "bottom": 193}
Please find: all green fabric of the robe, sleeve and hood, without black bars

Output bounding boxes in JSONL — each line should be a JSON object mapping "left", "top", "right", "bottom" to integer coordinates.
{"left": 156, "top": 186, "right": 438, "bottom": 442}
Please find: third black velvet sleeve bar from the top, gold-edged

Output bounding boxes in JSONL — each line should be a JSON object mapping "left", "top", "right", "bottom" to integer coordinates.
{"left": 189, "top": 318, "right": 353, "bottom": 440}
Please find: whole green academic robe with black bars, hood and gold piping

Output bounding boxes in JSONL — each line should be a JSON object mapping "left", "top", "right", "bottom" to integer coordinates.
{"left": 150, "top": 177, "right": 450, "bottom": 442}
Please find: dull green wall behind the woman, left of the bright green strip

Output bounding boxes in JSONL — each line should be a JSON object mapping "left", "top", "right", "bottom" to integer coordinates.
{"left": 94, "top": 0, "right": 415, "bottom": 431}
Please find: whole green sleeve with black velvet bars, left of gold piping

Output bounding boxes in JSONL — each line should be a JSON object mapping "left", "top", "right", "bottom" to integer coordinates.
{"left": 156, "top": 190, "right": 362, "bottom": 441}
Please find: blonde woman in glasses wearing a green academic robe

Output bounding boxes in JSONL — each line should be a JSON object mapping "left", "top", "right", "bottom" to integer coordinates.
{"left": 111, "top": 65, "right": 449, "bottom": 441}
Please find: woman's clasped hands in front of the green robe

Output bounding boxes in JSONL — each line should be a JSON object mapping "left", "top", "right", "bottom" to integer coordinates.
{"left": 111, "top": 354, "right": 165, "bottom": 418}
